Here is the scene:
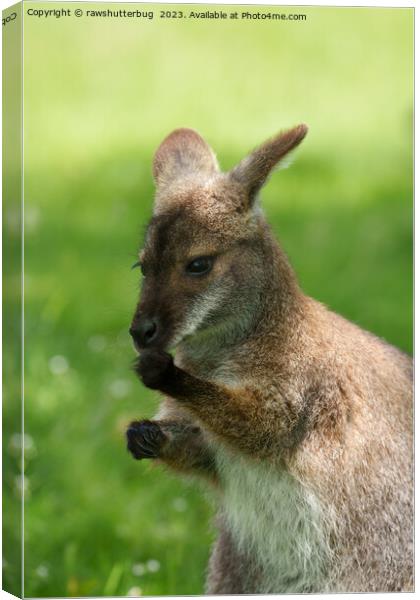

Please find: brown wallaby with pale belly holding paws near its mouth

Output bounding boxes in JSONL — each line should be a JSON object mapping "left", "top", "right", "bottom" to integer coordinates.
{"left": 127, "top": 125, "right": 413, "bottom": 594}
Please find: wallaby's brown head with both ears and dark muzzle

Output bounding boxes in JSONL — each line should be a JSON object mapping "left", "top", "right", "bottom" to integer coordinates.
{"left": 130, "top": 125, "right": 307, "bottom": 349}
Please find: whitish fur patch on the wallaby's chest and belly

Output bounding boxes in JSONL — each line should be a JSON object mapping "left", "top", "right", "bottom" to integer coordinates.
{"left": 216, "top": 447, "right": 328, "bottom": 593}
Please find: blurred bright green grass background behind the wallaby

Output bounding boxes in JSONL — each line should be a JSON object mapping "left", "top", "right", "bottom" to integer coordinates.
{"left": 4, "top": 3, "right": 413, "bottom": 596}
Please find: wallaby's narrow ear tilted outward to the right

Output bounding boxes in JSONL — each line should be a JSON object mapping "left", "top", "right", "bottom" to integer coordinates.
{"left": 230, "top": 124, "right": 308, "bottom": 208}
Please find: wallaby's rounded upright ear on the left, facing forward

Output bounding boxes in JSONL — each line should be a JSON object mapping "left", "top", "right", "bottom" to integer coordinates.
{"left": 153, "top": 129, "right": 219, "bottom": 187}
